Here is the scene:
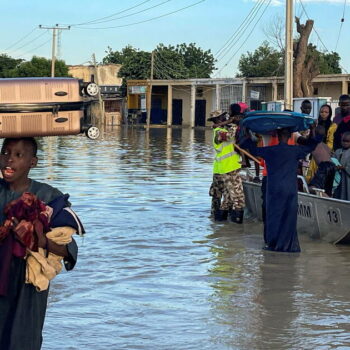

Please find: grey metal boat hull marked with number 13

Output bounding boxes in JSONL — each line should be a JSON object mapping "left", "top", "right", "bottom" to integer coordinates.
{"left": 243, "top": 180, "right": 350, "bottom": 244}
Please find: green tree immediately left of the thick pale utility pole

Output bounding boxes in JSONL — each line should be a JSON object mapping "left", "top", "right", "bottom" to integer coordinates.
{"left": 238, "top": 41, "right": 284, "bottom": 77}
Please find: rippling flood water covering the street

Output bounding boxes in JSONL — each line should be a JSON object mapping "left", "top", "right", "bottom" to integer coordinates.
{"left": 32, "top": 128, "right": 350, "bottom": 350}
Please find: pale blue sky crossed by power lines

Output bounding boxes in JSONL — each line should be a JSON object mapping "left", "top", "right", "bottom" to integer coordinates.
{"left": 0, "top": 0, "right": 350, "bottom": 77}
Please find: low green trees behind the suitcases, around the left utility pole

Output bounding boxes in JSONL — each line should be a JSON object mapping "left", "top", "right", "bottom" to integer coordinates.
{"left": 6, "top": 56, "right": 69, "bottom": 78}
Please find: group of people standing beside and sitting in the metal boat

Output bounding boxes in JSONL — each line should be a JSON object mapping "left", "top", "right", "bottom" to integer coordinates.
{"left": 208, "top": 95, "right": 350, "bottom": 252}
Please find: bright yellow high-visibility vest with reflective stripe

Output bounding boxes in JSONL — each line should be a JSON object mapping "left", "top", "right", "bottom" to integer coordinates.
{"left": 213, "top": 128, "right": 241, "bottom": 174}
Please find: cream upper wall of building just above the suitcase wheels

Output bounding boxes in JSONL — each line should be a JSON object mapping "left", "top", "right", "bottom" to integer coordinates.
{"left": 68, "top": 64, "right": 122, "bottom": 86}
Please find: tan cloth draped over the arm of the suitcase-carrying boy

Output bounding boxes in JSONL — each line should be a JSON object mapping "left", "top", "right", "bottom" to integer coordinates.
{"left": 26, "top": 226, "right": 76, "bottom": 292}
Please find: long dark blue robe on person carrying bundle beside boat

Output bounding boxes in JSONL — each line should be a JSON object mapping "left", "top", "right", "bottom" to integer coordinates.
{"left": 242, "top": 139, "right": 317, "bottom": 252}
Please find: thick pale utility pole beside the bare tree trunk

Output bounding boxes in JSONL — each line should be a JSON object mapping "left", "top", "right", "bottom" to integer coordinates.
{"left": 284, "top": 0, "right": 293, "bottom": 110}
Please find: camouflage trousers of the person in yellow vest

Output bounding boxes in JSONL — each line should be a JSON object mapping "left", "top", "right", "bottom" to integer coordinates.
{"left": 209, "top": 170, "right": 245, "bottom": 214}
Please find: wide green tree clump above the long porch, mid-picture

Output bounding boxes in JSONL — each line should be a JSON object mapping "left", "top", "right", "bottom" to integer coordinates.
{"left": 102, "top": 43, "right": 215, "bottom": 84}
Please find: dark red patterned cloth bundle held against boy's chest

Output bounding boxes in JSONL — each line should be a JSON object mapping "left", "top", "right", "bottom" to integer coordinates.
{"left": 0, "top": 192, "right": 50, "bottom": 251}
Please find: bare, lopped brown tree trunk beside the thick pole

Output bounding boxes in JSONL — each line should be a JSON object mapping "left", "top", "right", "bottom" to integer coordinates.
{"left": 293, "top": 17, "right": 317, "bottom": 97}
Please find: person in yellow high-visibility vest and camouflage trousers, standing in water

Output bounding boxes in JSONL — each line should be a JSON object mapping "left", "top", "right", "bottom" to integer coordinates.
{"left": 208, "top": 111, "right": 245, "bottom": 224}
